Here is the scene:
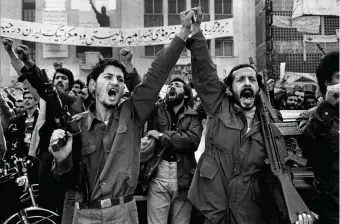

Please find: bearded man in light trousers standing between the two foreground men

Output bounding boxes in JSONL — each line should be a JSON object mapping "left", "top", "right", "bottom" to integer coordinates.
{"left": 143, "top": 78, "right": 203, "bottom": 224}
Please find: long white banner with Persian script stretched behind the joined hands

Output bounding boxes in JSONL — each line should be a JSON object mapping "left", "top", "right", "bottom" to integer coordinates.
{"left": 0, "top": 18, "right": 233, "bottom": 47}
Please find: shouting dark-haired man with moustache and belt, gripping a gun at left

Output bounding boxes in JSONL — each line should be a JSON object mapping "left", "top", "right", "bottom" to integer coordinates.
{"left": 46, "top": 12, "right": 194, "bottom": 224}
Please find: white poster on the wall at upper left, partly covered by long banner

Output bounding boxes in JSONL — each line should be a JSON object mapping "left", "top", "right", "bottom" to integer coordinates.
{"left": 42, "top": 6, "right": 68, "bottom": 58}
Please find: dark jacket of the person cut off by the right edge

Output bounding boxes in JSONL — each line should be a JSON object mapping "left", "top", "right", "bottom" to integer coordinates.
{"left": 297, "top": 101, "right": 339, "bottom": 223}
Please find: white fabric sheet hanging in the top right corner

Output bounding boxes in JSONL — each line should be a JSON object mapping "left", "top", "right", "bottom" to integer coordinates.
{"left": 292, "top": 0, "right": 339, "bottom": 19}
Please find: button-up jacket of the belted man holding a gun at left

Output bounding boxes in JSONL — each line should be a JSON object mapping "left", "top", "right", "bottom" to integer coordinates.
{"left": 54, "top": 36, "right": 185, "bottom": 204}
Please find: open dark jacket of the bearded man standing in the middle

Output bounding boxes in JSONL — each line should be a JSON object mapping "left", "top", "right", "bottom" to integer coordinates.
{"left": 143, "top": 102, "right": 203, "bottom": 198}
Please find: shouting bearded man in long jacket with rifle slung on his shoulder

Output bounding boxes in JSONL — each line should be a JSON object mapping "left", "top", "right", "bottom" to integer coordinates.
{"left": 187, "top": 7, "right": 312, "bottom": 224}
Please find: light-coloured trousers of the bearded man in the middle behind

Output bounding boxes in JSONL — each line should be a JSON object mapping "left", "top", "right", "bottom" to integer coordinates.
{"left": 147, "top": 160, "right": 192, "bottom": 224}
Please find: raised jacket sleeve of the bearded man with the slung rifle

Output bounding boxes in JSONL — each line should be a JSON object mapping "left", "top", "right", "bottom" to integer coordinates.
{"left": 187, "top": 32, "right": 225, "bottom": 115}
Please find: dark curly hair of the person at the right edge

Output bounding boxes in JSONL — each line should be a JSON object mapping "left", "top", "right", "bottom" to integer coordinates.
{"left": 316, "top": 51, "right": 339, "bottom": 95}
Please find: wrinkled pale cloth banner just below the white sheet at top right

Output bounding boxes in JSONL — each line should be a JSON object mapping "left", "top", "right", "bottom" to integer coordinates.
{"left": 273, "top": 15, "right": 321, "bottom": 33}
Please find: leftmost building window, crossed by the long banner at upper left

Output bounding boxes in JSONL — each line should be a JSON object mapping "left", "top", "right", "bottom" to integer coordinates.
{"left": 22, "top": 0, "right": 36, "bottom": 61}
